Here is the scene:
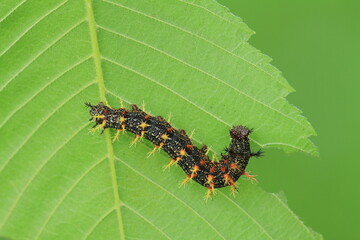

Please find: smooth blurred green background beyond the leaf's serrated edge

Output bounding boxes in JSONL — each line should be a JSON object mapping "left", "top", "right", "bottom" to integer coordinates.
{"left": 218, "top": 0, "right": 360, "bottom": 240}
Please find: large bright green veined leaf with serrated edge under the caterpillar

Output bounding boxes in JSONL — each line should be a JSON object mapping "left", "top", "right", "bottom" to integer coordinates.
{"left": 0, "top": 0, "right": 321, "bottom": 240}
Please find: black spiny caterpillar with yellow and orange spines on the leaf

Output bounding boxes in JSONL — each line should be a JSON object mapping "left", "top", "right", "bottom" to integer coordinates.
{"left": 86, "top": 102, "right": 262, "bottom": 199}
